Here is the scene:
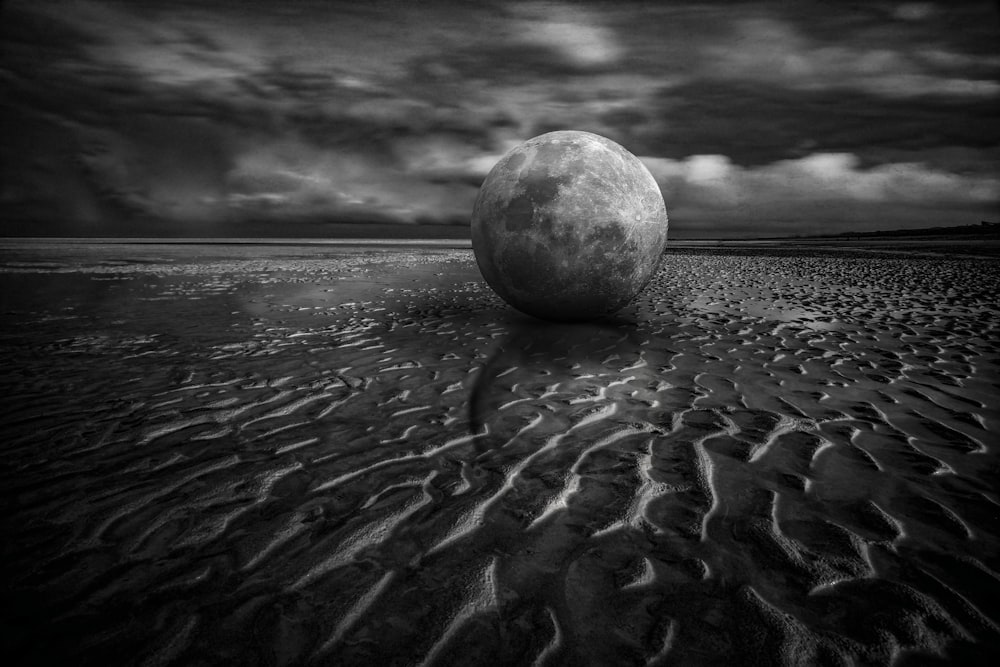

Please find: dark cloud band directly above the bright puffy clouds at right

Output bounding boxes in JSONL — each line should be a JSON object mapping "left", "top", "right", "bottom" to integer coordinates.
{"left": 631, "top": 81, "right": 1000, "bottom": 168}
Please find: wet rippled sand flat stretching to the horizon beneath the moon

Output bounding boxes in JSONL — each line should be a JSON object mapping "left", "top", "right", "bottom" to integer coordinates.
{"left": 0, "top": 244, "right": 1000, "bottom": 665}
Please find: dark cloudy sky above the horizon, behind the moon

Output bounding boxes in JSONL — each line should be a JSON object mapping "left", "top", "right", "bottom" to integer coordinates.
{"left": 0, "top": 0, "right": 1000, "bottom": 239}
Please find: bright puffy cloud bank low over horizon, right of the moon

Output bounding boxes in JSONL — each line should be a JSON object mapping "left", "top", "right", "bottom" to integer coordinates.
{"left": 642, "top": 153, "right": 1000, "bottom": 235}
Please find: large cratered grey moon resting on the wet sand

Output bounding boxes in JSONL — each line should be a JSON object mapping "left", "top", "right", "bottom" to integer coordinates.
{"left": 472, "top": 131, "right": 667, "bottom": 320}
